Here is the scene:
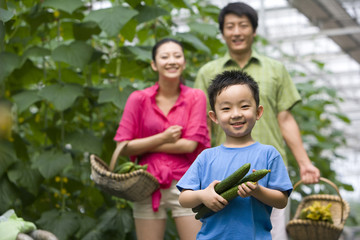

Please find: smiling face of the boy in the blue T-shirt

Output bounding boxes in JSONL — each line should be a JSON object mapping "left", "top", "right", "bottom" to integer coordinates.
{"left": 209, "top": 84, "right": 263, "bottom": 141}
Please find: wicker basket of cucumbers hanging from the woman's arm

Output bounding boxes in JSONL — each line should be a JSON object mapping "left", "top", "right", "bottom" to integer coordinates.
{"left": 90, "top": 141, "right": 159, "bottom": 202}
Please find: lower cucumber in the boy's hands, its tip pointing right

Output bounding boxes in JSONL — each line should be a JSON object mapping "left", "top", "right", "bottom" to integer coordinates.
{"left": 195, "top": 169, "right": 271, "bottom": 220}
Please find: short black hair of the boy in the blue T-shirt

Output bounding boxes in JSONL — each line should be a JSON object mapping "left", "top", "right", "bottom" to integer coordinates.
{"left": 208, "top": 70, "right": 260, "bottom": 112}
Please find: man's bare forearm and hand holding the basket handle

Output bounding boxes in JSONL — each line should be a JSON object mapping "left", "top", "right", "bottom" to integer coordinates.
{"left": 277, "top": 111, "right": 320, "bottom": 184}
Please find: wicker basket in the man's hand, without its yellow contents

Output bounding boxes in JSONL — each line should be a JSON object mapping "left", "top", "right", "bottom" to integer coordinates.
{"left": 286, "top": 177, "right": 350, "bottom": 240}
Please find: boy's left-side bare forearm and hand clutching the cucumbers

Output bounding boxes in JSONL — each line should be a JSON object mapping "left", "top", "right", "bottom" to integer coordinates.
{"left": 179, "top": 180, "right": 228, "bottom": 212}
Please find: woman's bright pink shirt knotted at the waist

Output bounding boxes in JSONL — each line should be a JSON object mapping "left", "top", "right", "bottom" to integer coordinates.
{"left": 114, "top": 83, "right": 210, "bottom": 211}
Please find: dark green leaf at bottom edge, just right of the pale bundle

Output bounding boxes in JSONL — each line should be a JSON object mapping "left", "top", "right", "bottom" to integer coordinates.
{"left": 36, "top": 209, "right": 81, "bottom": 239}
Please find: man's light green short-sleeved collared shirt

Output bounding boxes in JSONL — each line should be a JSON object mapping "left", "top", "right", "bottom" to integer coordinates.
{"left": 194, "top": 50, "right": 301, "bottom": 165}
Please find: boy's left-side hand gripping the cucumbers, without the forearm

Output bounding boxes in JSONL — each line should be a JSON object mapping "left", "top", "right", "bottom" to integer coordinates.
{"left": 201, "top": 180, "right": 228, "bottom": 212}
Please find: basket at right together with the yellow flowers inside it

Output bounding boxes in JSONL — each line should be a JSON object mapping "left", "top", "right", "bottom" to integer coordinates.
{"left": 286, "top": 178, "right": 350, "bottom": 240}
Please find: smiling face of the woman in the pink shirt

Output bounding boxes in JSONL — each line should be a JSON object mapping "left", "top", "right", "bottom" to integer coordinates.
{"left": 151, "top": 42, "right": 186, "bottom": 80}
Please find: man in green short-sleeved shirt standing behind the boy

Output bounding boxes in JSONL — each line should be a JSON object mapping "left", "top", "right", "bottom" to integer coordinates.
{"left": 194, "top": 2, "right": 320, "bottom": 240}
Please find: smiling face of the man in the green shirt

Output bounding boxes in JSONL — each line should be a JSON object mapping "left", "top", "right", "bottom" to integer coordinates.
{"left": 223, "top": 13, "right": 256, "bottom": 55}
